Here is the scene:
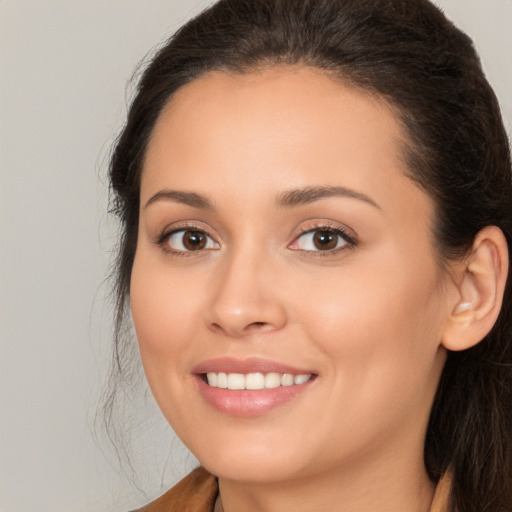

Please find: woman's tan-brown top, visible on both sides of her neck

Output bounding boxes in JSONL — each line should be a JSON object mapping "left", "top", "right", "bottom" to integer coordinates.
{"left": 134, "top": 467, "right": 451, "bottom": 512}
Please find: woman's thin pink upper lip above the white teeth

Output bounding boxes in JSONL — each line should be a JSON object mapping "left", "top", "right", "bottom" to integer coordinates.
{"left": 192, "top": 357, "right": 313, "bottom": 375}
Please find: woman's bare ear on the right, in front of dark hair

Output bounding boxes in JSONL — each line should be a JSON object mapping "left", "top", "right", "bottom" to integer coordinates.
{"left": 441, "top": 226, "right": 509, "bottom": 351}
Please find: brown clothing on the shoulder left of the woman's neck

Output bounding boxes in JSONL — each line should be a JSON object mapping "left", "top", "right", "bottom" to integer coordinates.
{"left": 133, "top": 467, "right": 218, "bottom": 512}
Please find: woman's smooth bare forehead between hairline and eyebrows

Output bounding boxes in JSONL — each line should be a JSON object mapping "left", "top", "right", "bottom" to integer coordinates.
{"left": 142, "top": 67, "right": 430, "bottom": 220}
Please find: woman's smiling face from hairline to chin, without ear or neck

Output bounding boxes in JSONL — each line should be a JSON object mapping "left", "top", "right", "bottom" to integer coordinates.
{"left": 131, "top": 68, "right": 447, "bottom": 483}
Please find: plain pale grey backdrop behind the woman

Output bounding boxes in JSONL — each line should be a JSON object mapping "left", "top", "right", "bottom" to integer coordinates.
{"left": 0, "top": 0, "right": 512, "bottom": 512}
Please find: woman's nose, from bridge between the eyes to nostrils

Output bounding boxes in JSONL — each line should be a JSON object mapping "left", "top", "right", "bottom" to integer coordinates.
{"left": 206, "top": 252, "right": 287, "bottom": 337}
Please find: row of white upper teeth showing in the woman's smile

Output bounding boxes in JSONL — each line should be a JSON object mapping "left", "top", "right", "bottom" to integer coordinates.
{"left": 206, "top": 372, "right": 312, "bottom": 390}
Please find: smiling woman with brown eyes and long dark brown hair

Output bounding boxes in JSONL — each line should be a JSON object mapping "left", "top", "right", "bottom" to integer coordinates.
{"left": 106, "top": 0, "right": 512, "bottom": 512}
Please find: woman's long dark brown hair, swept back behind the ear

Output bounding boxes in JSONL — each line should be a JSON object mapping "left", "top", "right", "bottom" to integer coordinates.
{"left": 106, "top": 0, "right": 512, "bottom": 512}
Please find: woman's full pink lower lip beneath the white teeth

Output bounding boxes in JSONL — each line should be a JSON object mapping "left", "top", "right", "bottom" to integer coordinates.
{"left": 197, "top": 375, "right": 314, "bottom": 418}
